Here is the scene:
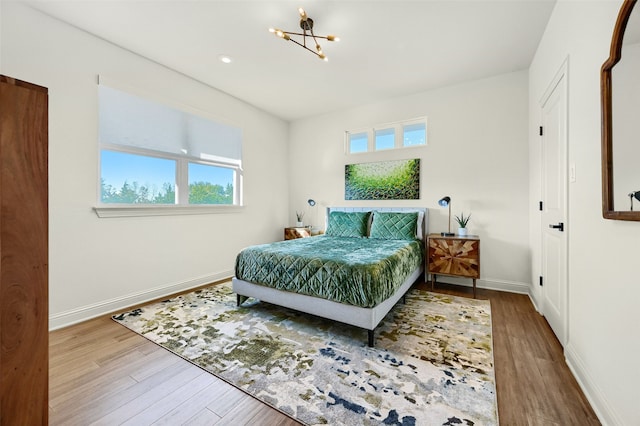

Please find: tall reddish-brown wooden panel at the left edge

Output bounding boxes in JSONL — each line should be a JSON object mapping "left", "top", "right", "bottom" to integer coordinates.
{"left": 0, "top": 76, "right": 49, "bottom": 425}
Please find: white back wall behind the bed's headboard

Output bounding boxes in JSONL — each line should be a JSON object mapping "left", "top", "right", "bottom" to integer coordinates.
{"left": 289, "top": 71, "right": 531, "bottom": 292}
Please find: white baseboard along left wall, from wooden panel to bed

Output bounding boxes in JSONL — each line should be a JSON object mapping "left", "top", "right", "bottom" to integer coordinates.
{"left": 49, "top": 271, "right": 233, "bottom": 331}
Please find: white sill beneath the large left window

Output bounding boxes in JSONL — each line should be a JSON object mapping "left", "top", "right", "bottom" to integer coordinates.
{"left": 93, "top": 205, "right": 242, "bottom": 218}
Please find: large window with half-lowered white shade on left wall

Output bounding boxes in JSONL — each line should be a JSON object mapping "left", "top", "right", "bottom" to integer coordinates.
{"left": 99, "top": 84, "right": 242, "bottom": 206}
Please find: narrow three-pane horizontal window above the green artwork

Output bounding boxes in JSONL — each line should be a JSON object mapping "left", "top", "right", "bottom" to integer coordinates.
{"left": 345, "top": 117, "right": 427, "bottom": 154}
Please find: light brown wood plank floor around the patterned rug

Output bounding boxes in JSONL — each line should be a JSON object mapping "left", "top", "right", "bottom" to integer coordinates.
{"left": 49, "top": 283, "right": 600, "bottom": 426}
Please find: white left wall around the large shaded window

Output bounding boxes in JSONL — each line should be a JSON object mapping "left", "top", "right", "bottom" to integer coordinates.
{"left": 1, "top": 2, "right": 289, "bottom": 328}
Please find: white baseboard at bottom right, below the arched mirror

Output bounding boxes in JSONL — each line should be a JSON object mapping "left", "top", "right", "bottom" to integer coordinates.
{"left": 564, "top": 342, "right": 623, "bottom": 426}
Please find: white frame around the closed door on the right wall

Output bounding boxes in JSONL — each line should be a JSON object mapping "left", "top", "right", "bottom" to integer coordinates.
{"left": 538, "top": 56, "right": 571, "bottom": 348}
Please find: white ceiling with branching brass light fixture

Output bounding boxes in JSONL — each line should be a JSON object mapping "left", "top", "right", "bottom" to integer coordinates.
{"left": 23, "top": 0, "right": 555, "bottom": 120}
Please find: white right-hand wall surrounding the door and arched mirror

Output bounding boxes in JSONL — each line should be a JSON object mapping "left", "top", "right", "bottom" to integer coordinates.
{"left": 529, "top": 0, "right": 640, "bottom": 425}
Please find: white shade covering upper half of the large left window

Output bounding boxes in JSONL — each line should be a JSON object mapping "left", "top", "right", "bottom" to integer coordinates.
{"left": 98, "top": 84, "right": 242, "bottom": 166}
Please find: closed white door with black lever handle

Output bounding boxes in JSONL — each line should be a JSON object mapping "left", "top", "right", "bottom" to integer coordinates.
{"left": 540, "top": 67, "right": 568, "bottom": 347}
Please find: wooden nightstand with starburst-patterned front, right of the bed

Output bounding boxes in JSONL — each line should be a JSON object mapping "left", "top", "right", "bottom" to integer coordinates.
{"left": 426, "top": 234, "right": 480, "bottom": 299}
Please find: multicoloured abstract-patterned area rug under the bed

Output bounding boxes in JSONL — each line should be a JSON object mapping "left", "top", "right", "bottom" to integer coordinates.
{"left": 113, "top": 283, "right": 498, "bottom": 425}
